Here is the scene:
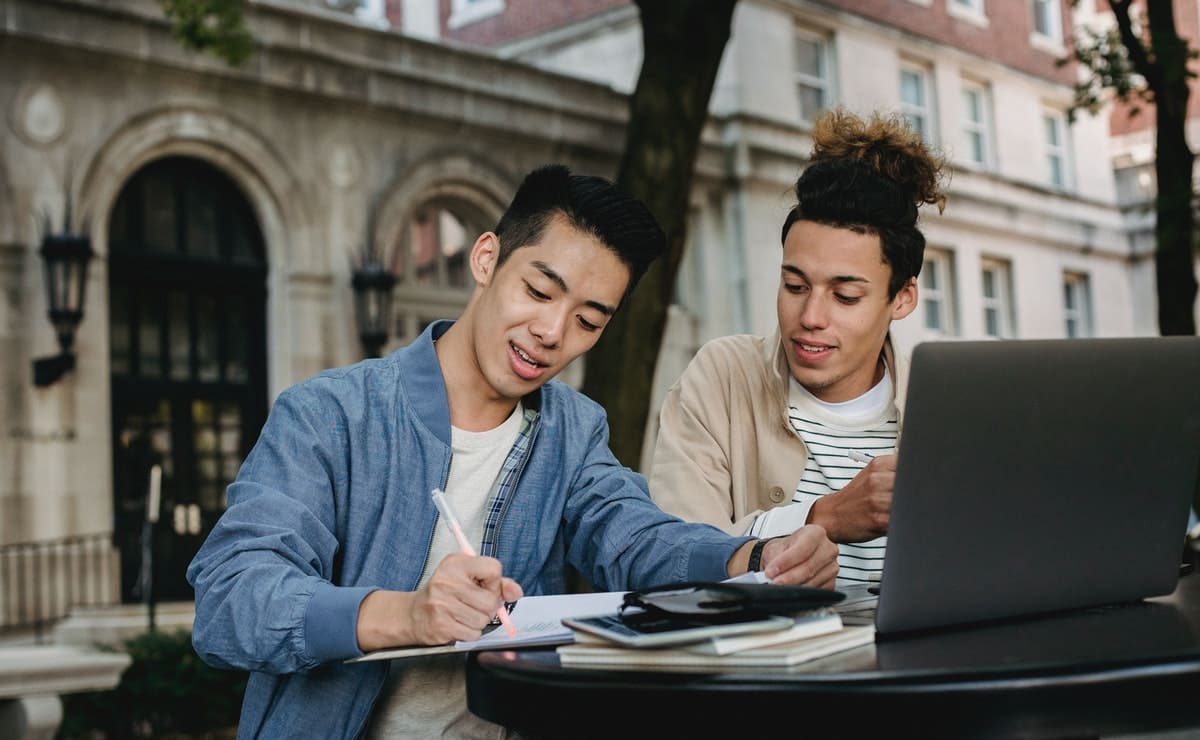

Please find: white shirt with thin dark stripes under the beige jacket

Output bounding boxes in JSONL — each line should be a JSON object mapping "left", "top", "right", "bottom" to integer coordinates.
{"left": 749, "top": 371, "right": 899, "bottom": 586}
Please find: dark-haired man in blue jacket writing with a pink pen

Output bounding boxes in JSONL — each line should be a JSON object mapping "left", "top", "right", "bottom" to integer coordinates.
{"left": 188, "top": 167, "right": 836, "bottom": 738}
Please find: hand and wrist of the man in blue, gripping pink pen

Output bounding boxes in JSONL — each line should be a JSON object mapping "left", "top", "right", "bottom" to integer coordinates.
{"left": 356, "top": 553, "right": 523, "bottom": 652}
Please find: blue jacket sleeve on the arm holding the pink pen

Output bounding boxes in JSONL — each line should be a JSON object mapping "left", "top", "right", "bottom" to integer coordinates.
{"left": 187, "top": 390, "right": 373, "bottom": 673}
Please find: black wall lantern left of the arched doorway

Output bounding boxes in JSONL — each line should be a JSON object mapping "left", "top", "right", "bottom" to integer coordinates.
{"left": 34, "top": 218, "right": 95, "bottom": 387}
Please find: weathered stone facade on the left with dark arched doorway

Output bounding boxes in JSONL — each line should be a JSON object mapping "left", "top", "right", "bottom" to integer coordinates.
{"left": 0, "top": 0, "right": 626, "bottom": 611}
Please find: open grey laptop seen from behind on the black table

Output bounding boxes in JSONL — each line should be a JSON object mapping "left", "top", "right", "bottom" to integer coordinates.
{"left": 842, "top": 337, "right": 1200, "bottom": 636}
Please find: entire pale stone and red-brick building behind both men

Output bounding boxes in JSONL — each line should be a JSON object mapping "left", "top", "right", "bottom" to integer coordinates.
{"left": 0, "top": 0, "right": 1154, "bottom": 625}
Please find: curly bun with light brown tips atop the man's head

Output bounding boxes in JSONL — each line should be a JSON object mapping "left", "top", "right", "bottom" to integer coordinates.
{"left": 811, "top": 108, "right": 946, "bottom": 212}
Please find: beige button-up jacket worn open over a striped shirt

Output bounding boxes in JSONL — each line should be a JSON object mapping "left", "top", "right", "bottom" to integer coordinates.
{"left": 650, "top": 331, "right": 907, "bottom": 535}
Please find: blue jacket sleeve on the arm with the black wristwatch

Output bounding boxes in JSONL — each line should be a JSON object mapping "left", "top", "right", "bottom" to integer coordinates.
{"left": 564, "top": 402, "right": 748, "bottom": 590}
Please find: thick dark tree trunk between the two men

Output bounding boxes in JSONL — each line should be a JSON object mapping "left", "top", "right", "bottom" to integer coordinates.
{"left": 583, "top": 0, "right": 737, "bottom": 469}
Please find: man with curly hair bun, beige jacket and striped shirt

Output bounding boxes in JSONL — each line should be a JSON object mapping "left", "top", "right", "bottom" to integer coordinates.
{"left": 650, "top": 110, "right": 944, "bottom": 585}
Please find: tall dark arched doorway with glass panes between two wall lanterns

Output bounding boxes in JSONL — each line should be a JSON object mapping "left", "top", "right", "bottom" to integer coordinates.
{"left": 108, "top": 157, "right": 266, "bottom": 601}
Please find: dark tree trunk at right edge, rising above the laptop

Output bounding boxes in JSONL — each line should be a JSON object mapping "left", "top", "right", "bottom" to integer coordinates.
{"left": 1147, "top": 0, "right": 1196, "bottom": 336}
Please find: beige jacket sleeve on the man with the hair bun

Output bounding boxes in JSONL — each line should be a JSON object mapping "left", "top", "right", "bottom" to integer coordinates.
{"left": 650, "top": 343, "right": 761, "bottom": 535}
